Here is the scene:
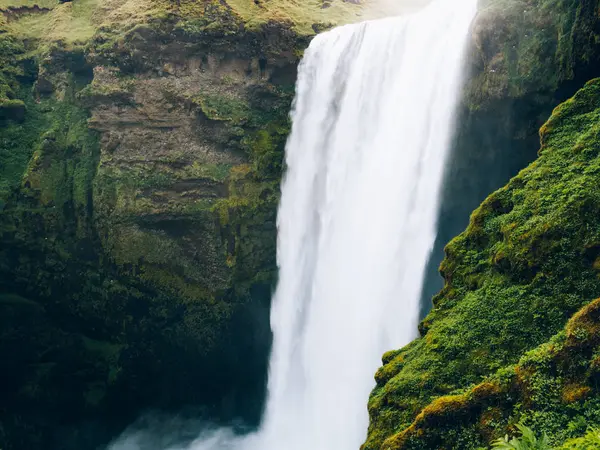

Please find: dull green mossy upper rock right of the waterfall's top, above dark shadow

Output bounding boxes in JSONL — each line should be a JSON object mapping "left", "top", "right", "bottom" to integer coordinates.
{"left": 466, "top": 0, "right": 600, "bottom": 109}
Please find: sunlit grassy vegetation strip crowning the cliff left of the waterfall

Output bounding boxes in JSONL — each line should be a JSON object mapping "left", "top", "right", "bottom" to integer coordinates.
{"left": 0, "top": 0, "right": 382, "bottom": 44}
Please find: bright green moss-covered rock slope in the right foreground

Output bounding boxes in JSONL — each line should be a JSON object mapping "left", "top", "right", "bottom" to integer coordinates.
{"left": 363, "top": 80, "right": 600, "bottom": 449}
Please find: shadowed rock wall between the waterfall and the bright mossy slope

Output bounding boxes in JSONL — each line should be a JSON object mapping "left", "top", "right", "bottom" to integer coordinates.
{"left": 422, "top": 0, "right": 600, "bottom": 314}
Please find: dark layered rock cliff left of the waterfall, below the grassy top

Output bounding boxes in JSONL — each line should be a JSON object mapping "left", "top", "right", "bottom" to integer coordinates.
{"left": 0, "top": 3, "right": 307, "bottom": 450}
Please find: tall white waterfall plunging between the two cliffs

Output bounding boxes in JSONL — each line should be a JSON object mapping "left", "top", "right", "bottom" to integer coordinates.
{"left": 110, "top": 0, "right": 477, "bottom": 450}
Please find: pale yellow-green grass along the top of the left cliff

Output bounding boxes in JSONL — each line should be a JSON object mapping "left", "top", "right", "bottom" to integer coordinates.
{"left": 0, "top": 0, "right": 428, "bottom": 43}
